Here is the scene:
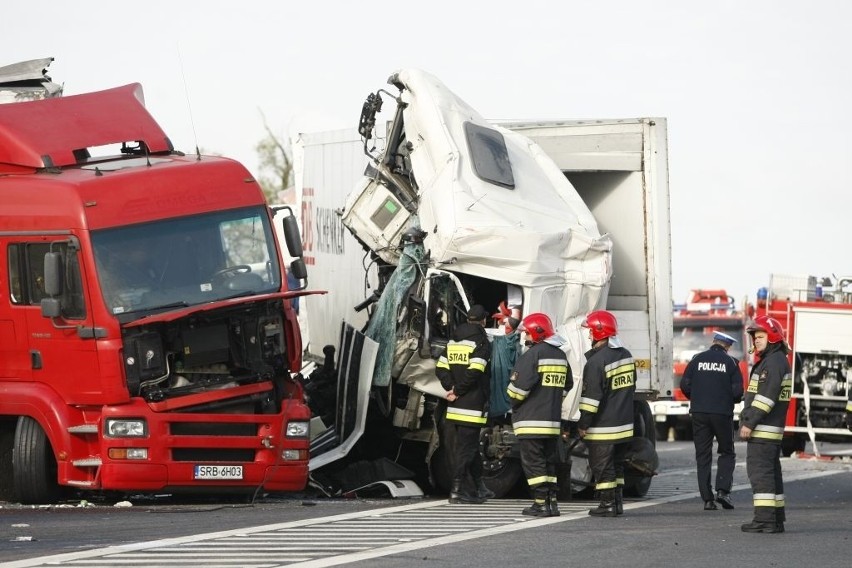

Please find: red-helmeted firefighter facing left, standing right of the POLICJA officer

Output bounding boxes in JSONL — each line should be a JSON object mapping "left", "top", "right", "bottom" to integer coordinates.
{"left": 740, "top": 316, "right": 793, "bottom": 533}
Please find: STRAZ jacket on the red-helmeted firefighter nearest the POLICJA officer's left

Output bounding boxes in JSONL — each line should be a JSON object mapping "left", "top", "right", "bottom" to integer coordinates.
{"left": 577, "top": 338, "right": 636, "bottom": 444}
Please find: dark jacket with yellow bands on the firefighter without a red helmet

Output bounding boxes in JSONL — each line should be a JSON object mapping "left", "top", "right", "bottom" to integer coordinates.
{"left": 435, "top": 322, "right": 491, "bottom": 427}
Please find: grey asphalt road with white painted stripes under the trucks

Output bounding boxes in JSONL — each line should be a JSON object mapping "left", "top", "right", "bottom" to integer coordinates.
{"left": 0, "top": 442, "right": 852, "bottom": 568}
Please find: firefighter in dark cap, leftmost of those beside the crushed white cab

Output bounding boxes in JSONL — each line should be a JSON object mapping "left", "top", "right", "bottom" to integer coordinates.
{"left": 435, "top": 304, "right": 494, "bottom": 503}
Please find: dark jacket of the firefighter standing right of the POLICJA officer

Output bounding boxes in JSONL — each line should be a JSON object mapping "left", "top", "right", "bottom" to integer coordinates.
{"left": 740, "top": 343, "right": 793, "bottom": 444}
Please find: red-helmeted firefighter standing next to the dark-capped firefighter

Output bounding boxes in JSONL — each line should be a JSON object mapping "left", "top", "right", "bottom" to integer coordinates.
{"left": 506, "top": 313, "right": 574, "bottom": 517}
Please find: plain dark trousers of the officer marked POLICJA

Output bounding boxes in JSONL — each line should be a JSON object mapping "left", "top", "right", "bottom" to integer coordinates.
{"left": 692, "top": 412, "right": 737, "bottom": 501}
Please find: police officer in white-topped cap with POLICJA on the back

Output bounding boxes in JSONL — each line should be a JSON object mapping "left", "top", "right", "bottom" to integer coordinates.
{"left": 680, "top": 331, "right": 743, "bottom": 511}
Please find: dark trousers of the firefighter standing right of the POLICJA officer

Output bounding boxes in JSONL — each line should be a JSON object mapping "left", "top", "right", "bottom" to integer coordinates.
{"left": 746, "top": 441, "right": 787, "bottom": 523}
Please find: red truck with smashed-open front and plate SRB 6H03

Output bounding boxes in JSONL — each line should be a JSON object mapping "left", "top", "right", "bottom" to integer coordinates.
{"left": 0, "top": 63, "right": 310, "bottom": 503}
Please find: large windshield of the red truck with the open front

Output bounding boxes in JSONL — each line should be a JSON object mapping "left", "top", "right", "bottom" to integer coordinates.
{"left": 92, "top": 207, "right": 281, "bottom": 314}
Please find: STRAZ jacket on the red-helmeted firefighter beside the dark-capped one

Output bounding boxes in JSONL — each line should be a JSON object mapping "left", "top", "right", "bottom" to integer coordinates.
{"left": 506, "top": 340, "right": 574, "bottom": 438}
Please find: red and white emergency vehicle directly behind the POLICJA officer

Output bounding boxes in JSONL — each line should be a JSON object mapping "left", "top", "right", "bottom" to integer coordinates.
{"left": 654, "top": 289, "right": 749, "bottom": 440}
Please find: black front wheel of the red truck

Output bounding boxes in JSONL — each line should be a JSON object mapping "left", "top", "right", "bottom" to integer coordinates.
{"left": 12, "top": 416, "right": 60, "bottom": 504}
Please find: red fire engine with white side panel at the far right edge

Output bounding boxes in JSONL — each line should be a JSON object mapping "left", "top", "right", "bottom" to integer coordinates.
{"left": 756, "top": 274, "right": 852, "bottom": 456}
